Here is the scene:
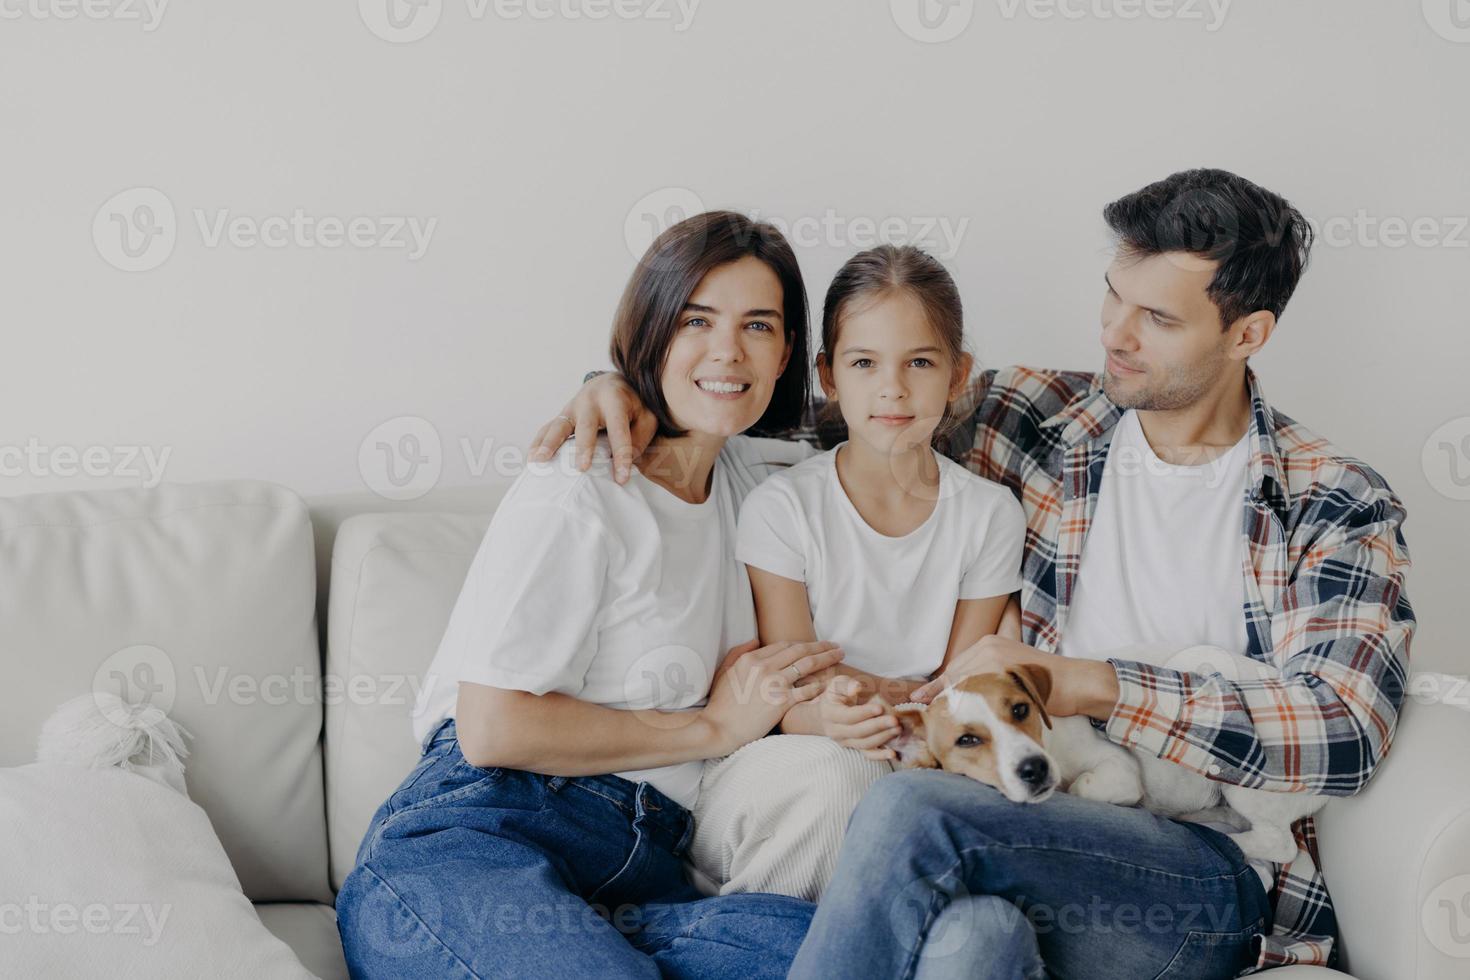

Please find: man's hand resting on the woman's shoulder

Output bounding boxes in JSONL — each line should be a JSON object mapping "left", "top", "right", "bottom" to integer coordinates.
{"left": 531, "top": 373, "right": 659, "bottom": 483}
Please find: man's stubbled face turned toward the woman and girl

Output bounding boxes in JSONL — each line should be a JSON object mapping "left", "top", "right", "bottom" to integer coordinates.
{"left": 1103, "top": 251, "right": 1233, "bottom": 411}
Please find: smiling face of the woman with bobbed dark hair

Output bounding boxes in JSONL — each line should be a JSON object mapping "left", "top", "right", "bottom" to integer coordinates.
{"left": 659, "top": 256, "right": 791, "bottom": 436}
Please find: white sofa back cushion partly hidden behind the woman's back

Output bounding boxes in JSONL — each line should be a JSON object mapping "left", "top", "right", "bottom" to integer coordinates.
{"left": 326, "top": 514, "right": 498, "bottom": 889}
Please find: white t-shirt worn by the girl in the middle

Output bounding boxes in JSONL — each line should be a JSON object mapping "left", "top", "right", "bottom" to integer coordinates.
{"left": 735, "top": 447, "right": 1026, "bottom": 679}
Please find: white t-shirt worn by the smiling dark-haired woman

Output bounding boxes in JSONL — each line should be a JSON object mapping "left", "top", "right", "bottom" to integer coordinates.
{"left": 413, "top": 436, "right": 813, "bottom": 807}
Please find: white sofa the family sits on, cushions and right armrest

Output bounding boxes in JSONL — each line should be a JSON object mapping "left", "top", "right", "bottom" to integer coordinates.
{"left": 0, "top": 480, "right": 1470, "bottom": 980}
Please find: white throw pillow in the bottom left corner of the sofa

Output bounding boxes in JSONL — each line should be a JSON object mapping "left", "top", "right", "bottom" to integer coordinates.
{"left": 0, "top": 763, "right": 313, "bottom": 980}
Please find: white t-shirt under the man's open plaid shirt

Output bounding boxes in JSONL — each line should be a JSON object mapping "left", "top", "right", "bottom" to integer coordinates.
{"left": 1057, "top": 410, "right": 1274, "bottom": 890}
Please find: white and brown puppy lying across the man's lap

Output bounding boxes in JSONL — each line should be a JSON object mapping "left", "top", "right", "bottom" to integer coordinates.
{"left": 891, "top": 646, "right": 1327, "bottom": 864}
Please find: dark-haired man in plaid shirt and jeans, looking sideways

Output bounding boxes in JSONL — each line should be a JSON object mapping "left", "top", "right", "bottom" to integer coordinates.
{"left": 535, "top": 170, "right": 1414, "bottom": 980}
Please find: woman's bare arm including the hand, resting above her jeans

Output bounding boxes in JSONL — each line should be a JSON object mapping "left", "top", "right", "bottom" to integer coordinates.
{"left": 456, "top": 641, "right": 842, "bottom": 776}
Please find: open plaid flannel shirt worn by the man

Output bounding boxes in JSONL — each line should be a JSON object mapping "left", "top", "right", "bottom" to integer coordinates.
{"left": 794, "top": 367, "right": 1414, "bottom": 970}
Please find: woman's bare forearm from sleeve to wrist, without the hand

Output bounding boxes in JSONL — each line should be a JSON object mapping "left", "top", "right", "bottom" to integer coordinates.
{"left": 456, "top": 682, "right": 717, "bottom": 776}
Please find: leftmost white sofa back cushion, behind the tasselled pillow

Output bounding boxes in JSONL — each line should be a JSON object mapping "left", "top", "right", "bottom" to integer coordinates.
{"left": 0, "top": 480, "right": 331, "bottom": 902}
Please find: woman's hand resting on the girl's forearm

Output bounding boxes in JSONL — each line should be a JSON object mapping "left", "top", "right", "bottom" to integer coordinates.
{"left": 700, "top": 641, "right": 842, "bottom": 755}
